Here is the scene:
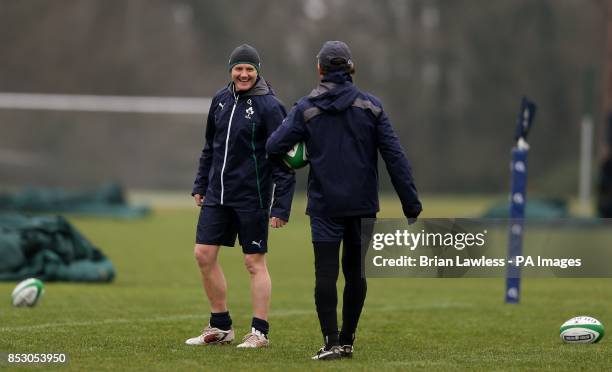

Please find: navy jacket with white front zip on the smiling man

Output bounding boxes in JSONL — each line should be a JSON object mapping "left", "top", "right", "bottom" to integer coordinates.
{"left": 192, "top": 77, "right": 295, "bottom": 221}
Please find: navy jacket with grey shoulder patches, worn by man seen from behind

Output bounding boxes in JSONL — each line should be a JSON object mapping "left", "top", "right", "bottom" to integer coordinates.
{"left": 266, "top": 72, "right": 422, "bottom": 218}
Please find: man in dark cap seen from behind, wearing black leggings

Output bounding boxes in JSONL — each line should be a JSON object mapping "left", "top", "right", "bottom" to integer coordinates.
{"left": 266, "top": 41, "right": 422, "bottom": 360}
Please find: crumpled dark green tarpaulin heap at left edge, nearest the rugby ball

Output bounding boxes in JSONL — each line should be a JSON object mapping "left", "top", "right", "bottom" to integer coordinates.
{"left": 0, "top": 213, "right": 115, "bottom": 282}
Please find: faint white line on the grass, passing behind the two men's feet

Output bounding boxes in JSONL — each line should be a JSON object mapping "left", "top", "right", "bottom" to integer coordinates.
{"left": 0, "top": 303, "right": 474, "bottom": 332}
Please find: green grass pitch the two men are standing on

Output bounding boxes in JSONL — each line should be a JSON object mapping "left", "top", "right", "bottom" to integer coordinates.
{"left": 0, "top": 196, "right": 612, "bottom": 371}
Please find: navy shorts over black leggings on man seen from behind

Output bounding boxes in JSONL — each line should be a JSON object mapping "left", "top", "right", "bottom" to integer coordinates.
{"left": 310, "top": 214, "right": 376, "bottom": 244}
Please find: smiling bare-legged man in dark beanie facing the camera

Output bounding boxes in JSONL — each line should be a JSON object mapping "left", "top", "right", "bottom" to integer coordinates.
{"left": 186, "top": 44, "right": 295, "bottom": 348}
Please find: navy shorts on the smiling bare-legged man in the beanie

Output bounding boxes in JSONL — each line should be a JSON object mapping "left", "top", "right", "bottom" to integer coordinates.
{"left": 196, "top": 205, "right": 268, "bottom": 254}
